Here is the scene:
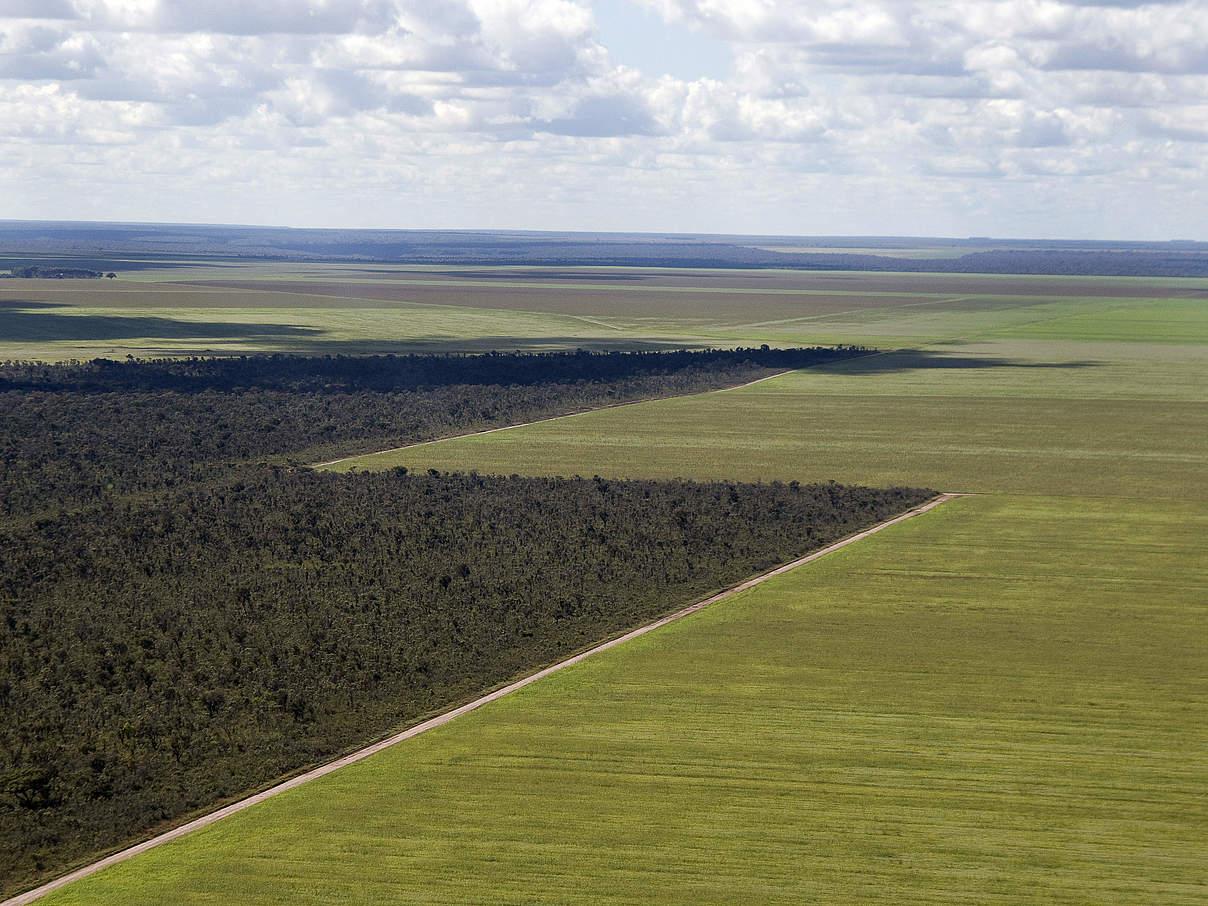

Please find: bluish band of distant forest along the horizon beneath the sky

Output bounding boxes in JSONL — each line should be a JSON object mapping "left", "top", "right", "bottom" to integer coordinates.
{"left": 0, "top": 221, "right": 1208, "bottom": 277}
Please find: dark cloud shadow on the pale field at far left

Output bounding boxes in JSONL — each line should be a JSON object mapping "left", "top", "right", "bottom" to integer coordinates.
{"left": 0, "top": 301, "right": 324, "bottom": 343}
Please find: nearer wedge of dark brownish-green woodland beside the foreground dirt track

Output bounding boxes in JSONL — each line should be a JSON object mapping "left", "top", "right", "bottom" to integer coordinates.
{"left": 0, "top": 467, "right": 930, "bottom": 889}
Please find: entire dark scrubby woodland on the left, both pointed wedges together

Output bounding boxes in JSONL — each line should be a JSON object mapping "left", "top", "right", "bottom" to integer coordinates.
{"left": 0, "top": 348, "right": 931, "bottom": 893}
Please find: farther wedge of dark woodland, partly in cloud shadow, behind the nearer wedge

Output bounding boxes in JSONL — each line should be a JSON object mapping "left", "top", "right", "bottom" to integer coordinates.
{"left": 0, "top": 348, "right": 866, "bottom": 518}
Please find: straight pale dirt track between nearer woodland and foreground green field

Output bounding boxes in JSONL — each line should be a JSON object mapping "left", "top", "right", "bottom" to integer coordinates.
{"left": 0, "top": 497, "right": 963, "bottom": 906}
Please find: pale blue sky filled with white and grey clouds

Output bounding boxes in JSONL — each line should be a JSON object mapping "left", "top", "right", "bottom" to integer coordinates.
{"left": 0, "top": 0, "right": 1208, "bottom": 239}
